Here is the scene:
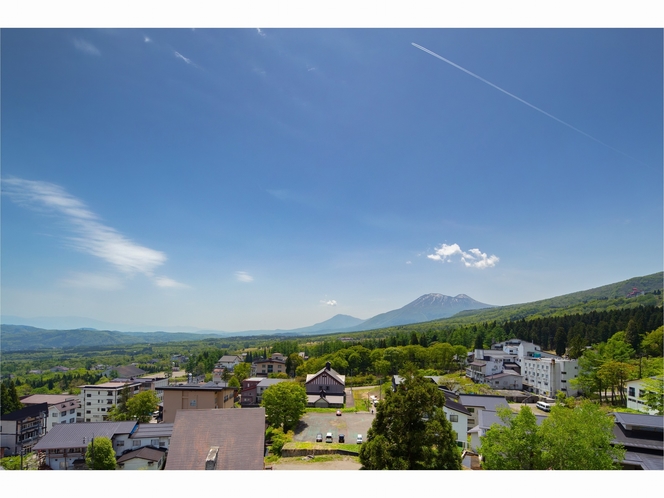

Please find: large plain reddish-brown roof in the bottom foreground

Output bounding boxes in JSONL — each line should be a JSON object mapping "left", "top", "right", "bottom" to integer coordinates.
{"left": 166, "top": 408, "right": 265, "bottom": 470}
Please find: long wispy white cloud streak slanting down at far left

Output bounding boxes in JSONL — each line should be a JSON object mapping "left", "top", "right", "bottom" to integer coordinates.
{"left": 2, "top": 178, "right": 185, "bottom": 285}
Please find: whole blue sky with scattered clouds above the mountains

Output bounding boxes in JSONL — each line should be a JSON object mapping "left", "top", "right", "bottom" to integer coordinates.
{"left": 1, "top": 28, "right": 663, "bottom": 331}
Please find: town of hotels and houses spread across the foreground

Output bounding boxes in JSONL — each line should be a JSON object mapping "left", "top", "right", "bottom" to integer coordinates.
{"left": 1, "top": 327, "right": 664, "bottom": 470}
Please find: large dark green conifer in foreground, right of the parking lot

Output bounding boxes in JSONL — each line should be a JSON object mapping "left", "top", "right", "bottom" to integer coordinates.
{"left": 360, "top": 369, "right": 461, "bottom": 470}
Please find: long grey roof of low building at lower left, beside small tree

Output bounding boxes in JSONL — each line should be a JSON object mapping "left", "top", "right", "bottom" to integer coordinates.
{"left": 34, "top": 422, "right": 137, "bottom": 450}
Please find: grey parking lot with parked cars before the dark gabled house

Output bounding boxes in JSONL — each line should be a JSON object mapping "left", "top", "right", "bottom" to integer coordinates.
{"left": 293, "top": 412, "right": 375, "bottom": 444}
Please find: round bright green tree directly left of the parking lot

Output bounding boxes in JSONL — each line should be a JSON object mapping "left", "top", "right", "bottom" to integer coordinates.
{"left": 261, "top": 381, "right": 307, "bottom": 431}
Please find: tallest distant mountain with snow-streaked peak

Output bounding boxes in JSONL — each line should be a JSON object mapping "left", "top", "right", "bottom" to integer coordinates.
{"left": 346, "top": 294, "right": 494, "bottom": 332}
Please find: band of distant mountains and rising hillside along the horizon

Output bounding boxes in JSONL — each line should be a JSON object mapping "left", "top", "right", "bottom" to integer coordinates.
{"left": 0, "top": 272, "right": 664, "bottom": 351}
